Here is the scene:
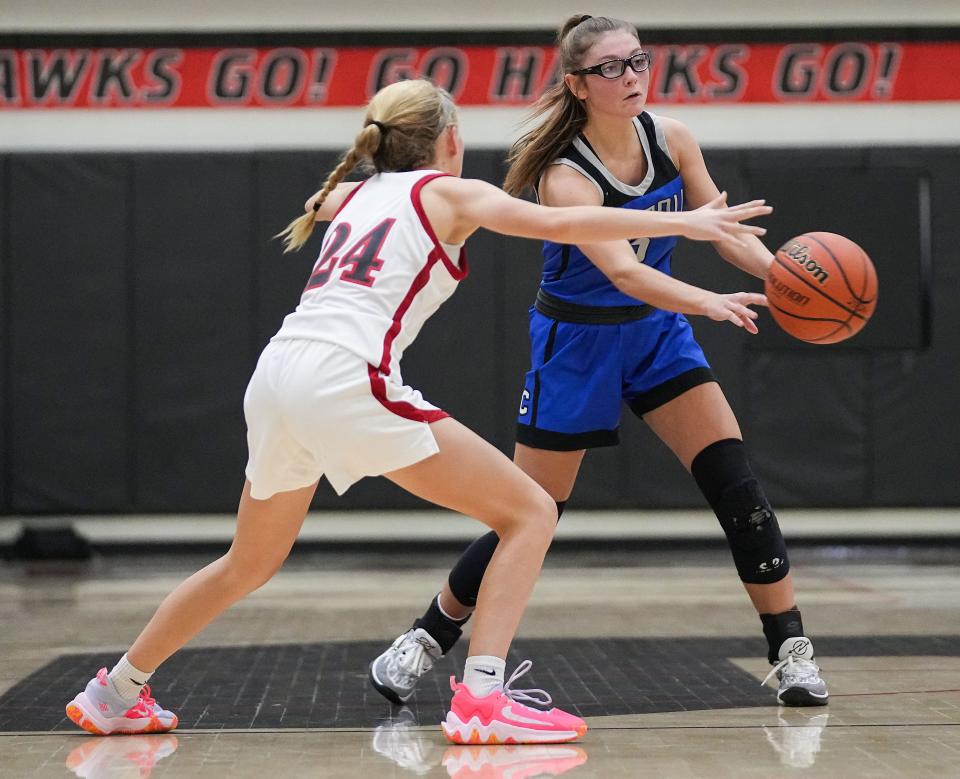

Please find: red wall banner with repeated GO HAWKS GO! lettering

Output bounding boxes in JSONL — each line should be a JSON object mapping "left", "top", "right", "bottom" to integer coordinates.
{"left": 0, "top": 41, "right": 960, "bottom": 110}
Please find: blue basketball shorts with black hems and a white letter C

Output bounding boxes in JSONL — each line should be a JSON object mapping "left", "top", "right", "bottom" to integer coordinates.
{"left": 517, "top": 308, "right": 716, "bottom": 451}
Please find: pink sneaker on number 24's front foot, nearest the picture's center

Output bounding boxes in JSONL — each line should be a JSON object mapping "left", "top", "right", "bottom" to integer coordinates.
{"left": 440, "top": 660, "right": 587, "bottom": 744}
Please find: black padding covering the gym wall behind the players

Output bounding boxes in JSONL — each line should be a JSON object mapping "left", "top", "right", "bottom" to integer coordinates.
{"left": 0, "top": 147, "right": 960, "bottom": 515}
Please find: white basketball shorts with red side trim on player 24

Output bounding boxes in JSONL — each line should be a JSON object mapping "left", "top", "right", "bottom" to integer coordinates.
{"left": 243, "top": 340, "right": 447, "bottom": 500}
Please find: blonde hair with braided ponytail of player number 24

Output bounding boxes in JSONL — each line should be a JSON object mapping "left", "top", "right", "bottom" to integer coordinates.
{"left": 274, "top": 80, "right": 457, "bottom": 254}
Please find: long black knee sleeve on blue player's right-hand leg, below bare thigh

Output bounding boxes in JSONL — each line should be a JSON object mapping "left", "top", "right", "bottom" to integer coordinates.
{"left": 690, "top": 438, "right": 790, "bottom": 584}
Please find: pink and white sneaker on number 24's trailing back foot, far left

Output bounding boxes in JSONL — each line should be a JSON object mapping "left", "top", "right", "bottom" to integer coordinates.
{"left": 67, "top": 668, "right": 178, "bottom": 736}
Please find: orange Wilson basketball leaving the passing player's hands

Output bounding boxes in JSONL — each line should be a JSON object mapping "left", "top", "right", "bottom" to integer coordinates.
{"left": 764, "top": 233, "right": 877, "bottom": 344}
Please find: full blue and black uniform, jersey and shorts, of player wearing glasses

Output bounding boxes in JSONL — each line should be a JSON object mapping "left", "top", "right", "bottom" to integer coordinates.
{"left": 517, "top": 113, "right": 716, "bottom": 451}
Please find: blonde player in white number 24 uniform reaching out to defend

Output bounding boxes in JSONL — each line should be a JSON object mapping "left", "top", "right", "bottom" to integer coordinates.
{"left": 67, "top": 81, "right": 771, "bottom": 743}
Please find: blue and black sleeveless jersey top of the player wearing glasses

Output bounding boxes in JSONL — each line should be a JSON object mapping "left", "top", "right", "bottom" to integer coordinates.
{"left": 540, "top": 111, "right": 683, "bottom": 306}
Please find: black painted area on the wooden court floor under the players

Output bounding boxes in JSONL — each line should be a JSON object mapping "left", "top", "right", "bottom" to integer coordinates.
{"left": 0, "top": 636, "right": 960, "bottom": 733}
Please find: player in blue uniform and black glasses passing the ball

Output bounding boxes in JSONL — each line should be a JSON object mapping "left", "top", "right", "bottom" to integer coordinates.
{"left": 370, "top": 15, "right": 828, "bottom": 706}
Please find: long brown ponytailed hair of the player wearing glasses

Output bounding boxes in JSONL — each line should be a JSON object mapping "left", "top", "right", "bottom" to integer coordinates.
{"left": 503, "top": 14, "right": 639, "bottom": 196}
